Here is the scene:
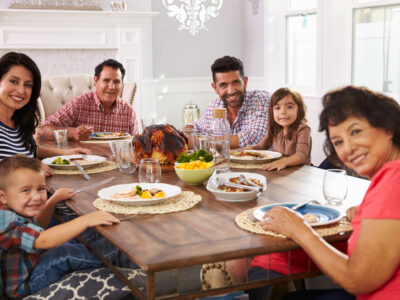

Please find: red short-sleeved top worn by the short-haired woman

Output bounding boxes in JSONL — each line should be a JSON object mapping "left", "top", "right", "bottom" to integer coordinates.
{"left": 348, "top": 159, "right": 400, "bottom": 300}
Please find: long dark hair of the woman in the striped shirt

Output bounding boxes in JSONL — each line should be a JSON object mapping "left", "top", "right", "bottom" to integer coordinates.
{"left": 0, "top": 52, "right": 42, "bottom": 152}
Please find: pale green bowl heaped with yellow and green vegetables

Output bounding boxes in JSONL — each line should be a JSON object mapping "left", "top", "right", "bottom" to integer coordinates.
{"left": 175, "top": 149, "right": 215, "bottom": 185}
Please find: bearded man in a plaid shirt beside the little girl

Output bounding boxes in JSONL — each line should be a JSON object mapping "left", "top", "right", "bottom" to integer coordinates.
{"left": 188, "top": 56, "right": 271, "bottom": 148}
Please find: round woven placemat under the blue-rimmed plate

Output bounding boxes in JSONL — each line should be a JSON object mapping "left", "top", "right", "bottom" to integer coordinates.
{"left": 235, "top": 208, "right": 352, "bottom": 238}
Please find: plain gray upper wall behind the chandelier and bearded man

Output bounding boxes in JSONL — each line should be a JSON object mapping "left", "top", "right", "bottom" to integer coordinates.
{"left": 152, "top": 0, "right": 264, "bottom": 78}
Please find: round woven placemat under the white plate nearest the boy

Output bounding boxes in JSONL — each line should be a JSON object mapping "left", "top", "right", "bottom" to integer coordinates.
{"left": 93, "top": 191, "right": 201, "bottom": 215}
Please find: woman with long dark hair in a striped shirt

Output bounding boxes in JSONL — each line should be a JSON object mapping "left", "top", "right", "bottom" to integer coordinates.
{"left": 0, "top": 52, "right": 90, "bottom": 171}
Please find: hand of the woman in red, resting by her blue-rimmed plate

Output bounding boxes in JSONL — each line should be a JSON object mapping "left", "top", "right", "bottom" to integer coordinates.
{"left": 260, "top": 206, "right": 311, "bottom": 239}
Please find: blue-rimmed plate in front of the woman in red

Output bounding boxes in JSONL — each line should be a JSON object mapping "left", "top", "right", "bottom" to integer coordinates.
{"left": 253, "top": 203, "right": 341, "bottom": 226}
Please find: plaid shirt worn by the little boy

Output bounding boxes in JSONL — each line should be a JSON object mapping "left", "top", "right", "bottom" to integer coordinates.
{"left": 0, "top": 204, "right": 43, "bottom": 299}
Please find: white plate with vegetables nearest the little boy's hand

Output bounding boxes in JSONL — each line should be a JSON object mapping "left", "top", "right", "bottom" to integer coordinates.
{"left": 97, "top": 182, "right": 182, "bottom": 205}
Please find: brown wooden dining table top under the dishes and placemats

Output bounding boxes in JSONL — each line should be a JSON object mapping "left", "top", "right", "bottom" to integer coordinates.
{"left": 43, "top": 144, "right": 369, "bottom": 272}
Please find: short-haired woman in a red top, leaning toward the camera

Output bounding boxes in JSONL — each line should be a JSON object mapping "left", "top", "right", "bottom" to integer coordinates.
{"left": 261, "top": 86, "right": 400, "bottom": 299}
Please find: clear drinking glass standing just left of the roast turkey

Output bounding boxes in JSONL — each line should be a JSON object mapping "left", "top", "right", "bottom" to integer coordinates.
{"left": 109, "top": 140, "right": 136, "bottom": 173}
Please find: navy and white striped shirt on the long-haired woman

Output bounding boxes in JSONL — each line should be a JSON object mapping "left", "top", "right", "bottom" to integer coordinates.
{"left": 0, "top": 122, "right": 34, "bottom": 159}
